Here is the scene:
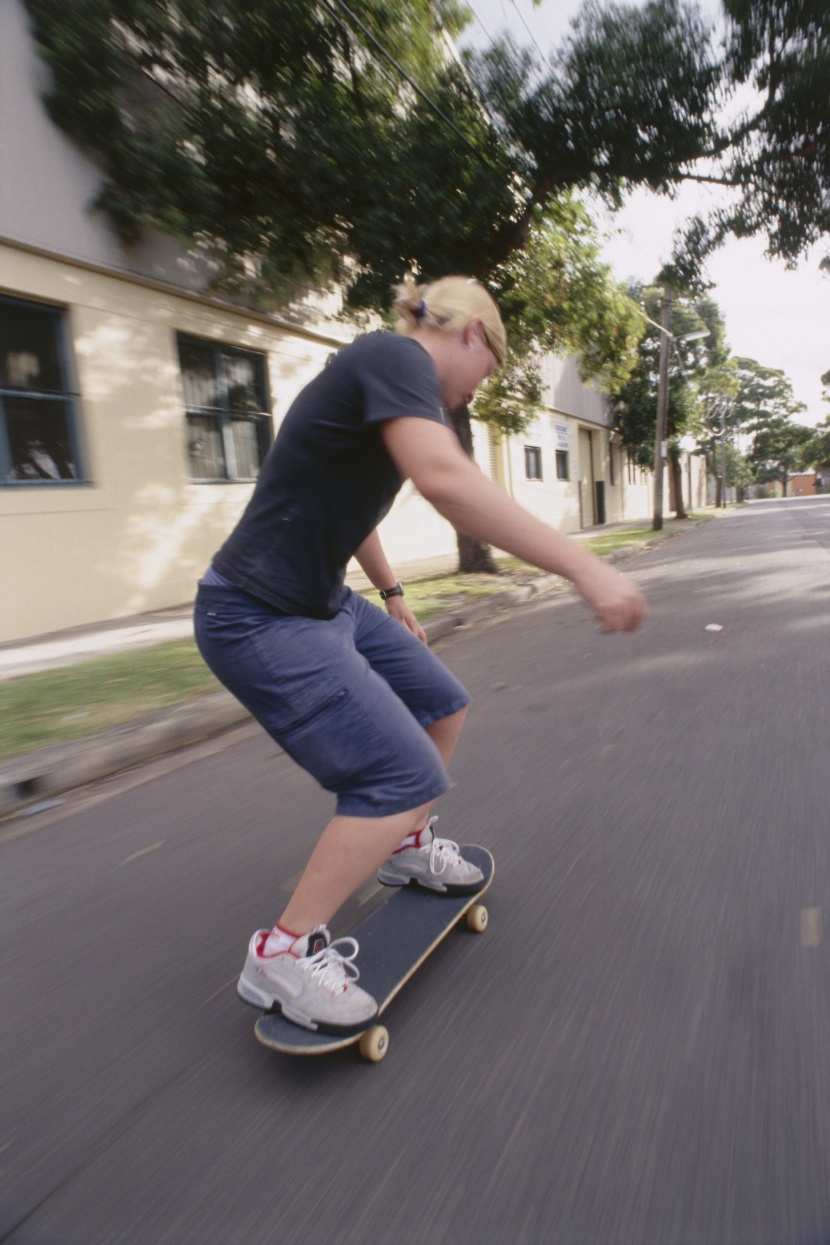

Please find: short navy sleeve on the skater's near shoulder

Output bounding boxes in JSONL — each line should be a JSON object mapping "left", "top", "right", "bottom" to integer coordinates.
{"left": 361, "top": 334, "right": 448, "bottom": 423}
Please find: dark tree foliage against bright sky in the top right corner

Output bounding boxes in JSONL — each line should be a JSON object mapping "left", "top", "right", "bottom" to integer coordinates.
{"left": 477, "top": 0, "right": 830, "bottom": 277}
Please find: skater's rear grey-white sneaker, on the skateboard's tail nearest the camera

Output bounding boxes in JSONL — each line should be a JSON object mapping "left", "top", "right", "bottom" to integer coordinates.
{"left": 236, "top": 925, "right": 377, "bottom": 1035}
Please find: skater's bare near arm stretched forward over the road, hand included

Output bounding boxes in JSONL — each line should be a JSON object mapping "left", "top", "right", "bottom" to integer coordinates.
{"left": 382, "top": 417, "right": 645, "bottom": 631}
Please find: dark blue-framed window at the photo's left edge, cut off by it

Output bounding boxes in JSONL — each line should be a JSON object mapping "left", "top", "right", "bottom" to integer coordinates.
{"left": 0, "top": 299, "right": 82, "bottom": 484}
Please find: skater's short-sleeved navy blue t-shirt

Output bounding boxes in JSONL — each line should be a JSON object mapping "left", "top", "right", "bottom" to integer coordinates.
{"left": 213, "top": 332, "right": 448, "bottom": 618}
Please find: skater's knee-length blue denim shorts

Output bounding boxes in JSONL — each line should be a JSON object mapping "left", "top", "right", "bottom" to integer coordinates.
{"left": 194, "top": 585, "right": 470, "bottom": 817}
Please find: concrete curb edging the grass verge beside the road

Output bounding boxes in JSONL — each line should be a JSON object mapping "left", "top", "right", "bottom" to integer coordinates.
{"left": 0, "top": 540, "right": 657, "bottom": 818}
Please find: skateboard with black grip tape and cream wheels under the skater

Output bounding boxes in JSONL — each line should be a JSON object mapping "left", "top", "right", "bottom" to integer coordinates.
{"left": 254, "top": 847, "right": 495, "bottom": 1063}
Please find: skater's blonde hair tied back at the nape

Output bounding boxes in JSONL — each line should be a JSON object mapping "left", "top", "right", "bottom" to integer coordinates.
{"left": 393, "top": 273, "right": 508, "bottom": 366}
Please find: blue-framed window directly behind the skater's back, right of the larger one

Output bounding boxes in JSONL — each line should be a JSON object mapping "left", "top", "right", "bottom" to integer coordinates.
{"left": 178, "top": 336, "right": 271, "bottom": 481}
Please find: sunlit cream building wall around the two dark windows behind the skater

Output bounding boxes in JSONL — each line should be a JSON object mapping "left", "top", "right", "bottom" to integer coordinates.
{"left": 0, "top": 247, "right": 455, "bottom": 641}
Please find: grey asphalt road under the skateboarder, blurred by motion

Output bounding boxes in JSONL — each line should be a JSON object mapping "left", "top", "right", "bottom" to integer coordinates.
{"left": 0, "top": 498, "right": 830, "bottom": 1245}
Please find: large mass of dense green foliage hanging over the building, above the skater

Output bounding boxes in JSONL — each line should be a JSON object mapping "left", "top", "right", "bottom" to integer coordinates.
{"left": 22, "top": 0, "right": 515, "bottom": 306}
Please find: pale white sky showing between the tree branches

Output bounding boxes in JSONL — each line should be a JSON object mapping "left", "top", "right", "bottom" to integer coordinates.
{"left": 459, "top": 0, "right": 830, "bottom": 423}
